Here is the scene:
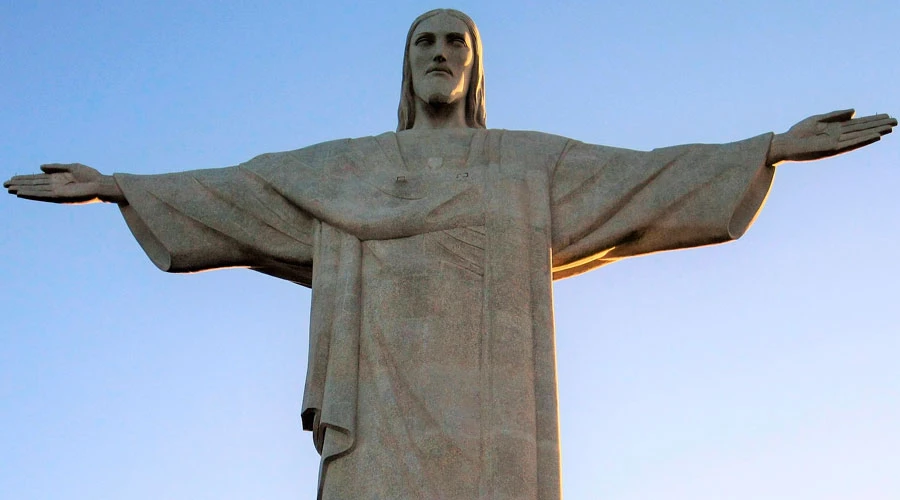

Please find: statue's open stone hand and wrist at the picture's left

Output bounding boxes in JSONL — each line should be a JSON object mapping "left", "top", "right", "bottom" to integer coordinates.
{"left": 3, "top": 163, "right": 127, "bottom": 204}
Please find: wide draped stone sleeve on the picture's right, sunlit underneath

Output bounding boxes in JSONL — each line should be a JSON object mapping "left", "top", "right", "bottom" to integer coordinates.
{"left": 550, "top": 134, "right": 775, "bottom": 279}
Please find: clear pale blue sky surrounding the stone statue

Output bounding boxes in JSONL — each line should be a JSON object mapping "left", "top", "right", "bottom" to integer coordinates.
{"left": 0, "top": 0, "right": 900, "bottom": 500}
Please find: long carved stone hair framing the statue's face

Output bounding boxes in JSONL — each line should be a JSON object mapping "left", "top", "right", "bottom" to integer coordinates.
{"left": 397, "top": 9, "right": 487, "bottom": 132}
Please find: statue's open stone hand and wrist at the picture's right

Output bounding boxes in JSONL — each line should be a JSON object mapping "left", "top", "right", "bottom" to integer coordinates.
{"left": 768, "top": 109, "right": 897, "bottom": 165}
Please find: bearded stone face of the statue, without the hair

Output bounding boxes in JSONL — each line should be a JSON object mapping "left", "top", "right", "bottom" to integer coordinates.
{"left": 409, "top": 14, "right": 474, "bottom": 105}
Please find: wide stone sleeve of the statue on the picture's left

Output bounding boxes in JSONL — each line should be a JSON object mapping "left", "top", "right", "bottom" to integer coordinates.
{"left": 115, "top": 166, "right": 317, "bottom": 286}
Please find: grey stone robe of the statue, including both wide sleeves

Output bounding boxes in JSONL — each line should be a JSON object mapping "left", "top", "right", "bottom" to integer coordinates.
{"left": 115, "top": 130, "right": 774, "bottom": 500}
